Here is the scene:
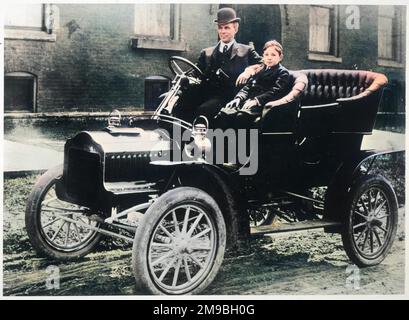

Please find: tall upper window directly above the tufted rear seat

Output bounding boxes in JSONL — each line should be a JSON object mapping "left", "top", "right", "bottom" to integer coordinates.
{"left": 309, "top": 6, "right": 340, "bottom": 62}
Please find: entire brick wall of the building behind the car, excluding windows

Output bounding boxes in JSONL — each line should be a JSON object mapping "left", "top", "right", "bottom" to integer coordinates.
{"left": 5, "top": 4, "right": 406, "bottom": 120}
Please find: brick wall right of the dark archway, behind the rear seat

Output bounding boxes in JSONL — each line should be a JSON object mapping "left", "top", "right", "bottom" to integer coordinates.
{"left": 280, "top": 5, "right": 406, "bottom": 129}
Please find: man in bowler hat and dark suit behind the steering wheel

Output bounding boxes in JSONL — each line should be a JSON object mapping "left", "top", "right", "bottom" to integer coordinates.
{"left": 196, "top": 8, "right": 262, "bottom": 121}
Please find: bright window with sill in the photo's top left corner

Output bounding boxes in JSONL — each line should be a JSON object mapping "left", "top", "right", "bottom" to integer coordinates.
{"left": 4, "top": 4, "right": 58, "bottom": 41}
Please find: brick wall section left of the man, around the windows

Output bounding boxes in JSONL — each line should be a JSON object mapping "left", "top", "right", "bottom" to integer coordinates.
{"left": 5, "top": 4, "right": 217, "bottom": 112}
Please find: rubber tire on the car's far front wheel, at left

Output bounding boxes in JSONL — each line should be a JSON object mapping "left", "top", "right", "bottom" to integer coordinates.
{"left": 25, "top": 165, "right": 101, "bottom": 261}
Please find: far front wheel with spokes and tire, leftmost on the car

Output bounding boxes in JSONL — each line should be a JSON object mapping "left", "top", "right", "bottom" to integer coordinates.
{"left": 25, "top": 166, "right": 101, "bottom": 260}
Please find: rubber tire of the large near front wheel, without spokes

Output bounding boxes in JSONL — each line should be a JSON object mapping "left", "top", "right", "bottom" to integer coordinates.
{"left": 132, "top": 187, "right": 226, "bottom": 295}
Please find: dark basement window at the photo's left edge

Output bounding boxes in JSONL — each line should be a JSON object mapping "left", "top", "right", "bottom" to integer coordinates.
{"left": 4, "top": 72, "right": 37, "bottom": 112}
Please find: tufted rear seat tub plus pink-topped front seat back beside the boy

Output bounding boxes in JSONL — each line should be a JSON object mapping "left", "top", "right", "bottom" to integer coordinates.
{"left": 262, "top": 69, "right": 388, "bottom": 137}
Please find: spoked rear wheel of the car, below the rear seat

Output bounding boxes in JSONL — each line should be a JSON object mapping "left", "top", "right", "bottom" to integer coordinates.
{"left": 342, "top": 175, "right": 398, "bottom": 267}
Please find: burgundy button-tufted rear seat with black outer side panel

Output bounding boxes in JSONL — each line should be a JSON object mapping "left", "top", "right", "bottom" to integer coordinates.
{"left": 297, "top": 69, "right": 388, "bottom": 136}
